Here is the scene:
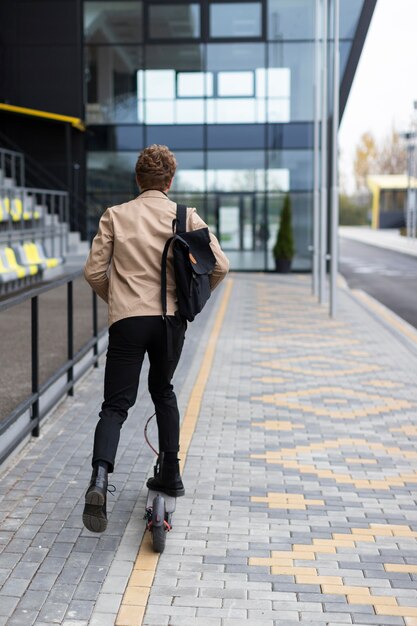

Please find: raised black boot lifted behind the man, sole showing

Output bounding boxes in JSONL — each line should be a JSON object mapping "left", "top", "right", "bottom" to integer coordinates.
{"left": 83, "top": 461, "right": 108, "bottom": 533}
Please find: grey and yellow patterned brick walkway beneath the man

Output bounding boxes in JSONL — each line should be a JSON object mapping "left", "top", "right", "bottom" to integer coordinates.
{"left": 0, "top": 274, "right": 417, "bottom": 626}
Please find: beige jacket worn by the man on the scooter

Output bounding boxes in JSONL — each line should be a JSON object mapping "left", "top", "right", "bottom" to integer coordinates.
{"left": 84, "top": 190, "right": 229, "bottom": 326}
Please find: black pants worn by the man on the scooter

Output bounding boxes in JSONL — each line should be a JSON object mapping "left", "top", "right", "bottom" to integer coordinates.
{"left": 92, "top": 315, "right": 186, "bottom": 472}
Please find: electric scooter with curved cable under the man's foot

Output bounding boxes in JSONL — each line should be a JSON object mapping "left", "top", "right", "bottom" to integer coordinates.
{"left": 144, "top": 413, "right": 177, "bottom": 553}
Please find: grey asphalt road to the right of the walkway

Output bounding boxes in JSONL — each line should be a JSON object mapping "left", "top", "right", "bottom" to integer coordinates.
{"left": 339, "top": 237, "right": 417, "bottom": 328}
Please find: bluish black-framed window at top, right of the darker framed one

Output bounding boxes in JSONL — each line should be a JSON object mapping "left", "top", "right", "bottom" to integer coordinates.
{"left": 210, "top": 2, "right": 262, "bottom": 38}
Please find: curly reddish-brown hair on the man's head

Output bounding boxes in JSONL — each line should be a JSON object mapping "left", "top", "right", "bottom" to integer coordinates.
{"left": 135, "top": 143, "right": 177, "bottom": 191}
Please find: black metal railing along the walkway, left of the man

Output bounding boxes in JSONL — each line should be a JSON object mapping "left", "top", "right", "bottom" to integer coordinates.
{"left": 0, "top": 270, "right": 107, "bottom": 463}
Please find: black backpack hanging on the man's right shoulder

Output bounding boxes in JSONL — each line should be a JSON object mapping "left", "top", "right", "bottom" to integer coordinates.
{"left": 161, "top": 204, "right": 216, "bottom": 322}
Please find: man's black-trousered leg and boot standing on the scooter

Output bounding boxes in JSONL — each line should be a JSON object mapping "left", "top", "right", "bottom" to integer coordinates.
{"left": 147, "top": 318, "right": 186, "bottom": 496}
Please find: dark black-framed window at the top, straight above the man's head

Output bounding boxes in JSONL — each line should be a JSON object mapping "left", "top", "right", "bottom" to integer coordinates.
{"left": 148, "top": 3, "right": 200, "bottom": 39}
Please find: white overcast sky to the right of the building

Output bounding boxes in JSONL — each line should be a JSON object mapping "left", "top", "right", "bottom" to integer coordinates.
{"left": 339, "top": 0, "right": 417, "bottom": 192}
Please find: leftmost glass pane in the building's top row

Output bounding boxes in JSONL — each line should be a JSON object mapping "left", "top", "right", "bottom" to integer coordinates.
{"left": 84, "top": 0, "right": 143, "bottom": 44}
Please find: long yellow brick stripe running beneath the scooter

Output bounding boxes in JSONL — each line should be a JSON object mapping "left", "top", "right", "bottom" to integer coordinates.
{"left": 115, "top": 279, "right": 233, "bottom": 626}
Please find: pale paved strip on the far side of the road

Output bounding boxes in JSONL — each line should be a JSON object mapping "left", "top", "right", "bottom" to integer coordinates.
{"left": 339, "top": 226, "right": 417, "bottom": 256}
